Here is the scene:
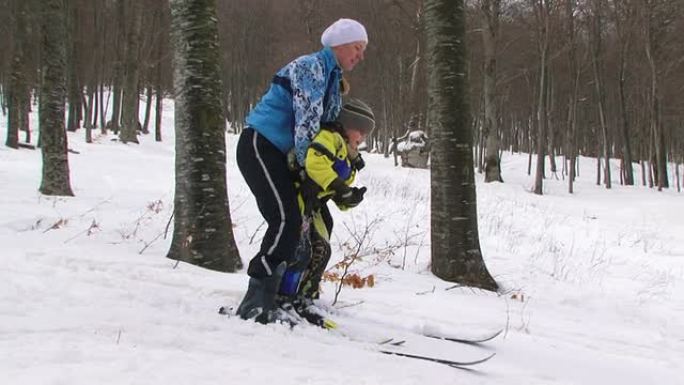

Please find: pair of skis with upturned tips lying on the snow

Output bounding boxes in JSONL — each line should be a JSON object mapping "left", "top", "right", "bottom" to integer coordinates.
{"left": 219, "top": 307, "right": 503, "bottom": 370}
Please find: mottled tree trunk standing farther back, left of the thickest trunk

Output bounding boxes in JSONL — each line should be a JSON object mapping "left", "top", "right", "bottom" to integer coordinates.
{"left": 39, "top": 0, "right": 74, "bottom": 196}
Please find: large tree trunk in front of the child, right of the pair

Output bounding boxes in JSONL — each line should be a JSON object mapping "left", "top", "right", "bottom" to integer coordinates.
{"left": 424, "top": 0, "right": 498, "bottom": 291}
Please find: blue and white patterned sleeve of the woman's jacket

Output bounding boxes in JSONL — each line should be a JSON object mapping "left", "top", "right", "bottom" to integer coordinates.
{"left": 290, "top": 57, "right": 326, "bottom": 166}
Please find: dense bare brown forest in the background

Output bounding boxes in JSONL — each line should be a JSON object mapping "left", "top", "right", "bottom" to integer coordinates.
{"left": 0, "top": 0, "right": 684, "bottom": 193}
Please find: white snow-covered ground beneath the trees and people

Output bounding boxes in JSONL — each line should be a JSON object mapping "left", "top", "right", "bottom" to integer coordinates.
{"left": 0, "top": 103, "right": 684, "bottom": 385}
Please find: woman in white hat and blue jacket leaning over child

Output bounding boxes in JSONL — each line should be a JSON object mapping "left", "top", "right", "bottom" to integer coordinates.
{"left": 237, "top": 19, "right": 368, "bottom": 323}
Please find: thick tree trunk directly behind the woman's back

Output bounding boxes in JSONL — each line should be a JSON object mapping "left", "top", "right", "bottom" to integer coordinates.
{"left": 167, "top": 0, "right": 242, "bottom": 272}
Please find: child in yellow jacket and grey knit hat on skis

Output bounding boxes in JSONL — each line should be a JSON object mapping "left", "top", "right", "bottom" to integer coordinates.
{"left": 278, "top": 99, "right": 375, "bottom": 328}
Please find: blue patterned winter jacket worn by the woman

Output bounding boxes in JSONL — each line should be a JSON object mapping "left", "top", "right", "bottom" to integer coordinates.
{"left": 246, "top": 47, "right": 342, "bottom": 166}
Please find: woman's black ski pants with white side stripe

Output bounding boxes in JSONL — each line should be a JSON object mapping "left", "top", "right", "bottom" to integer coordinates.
{"left": 237, "top": 128, "right": 302, "bottom": 267}
